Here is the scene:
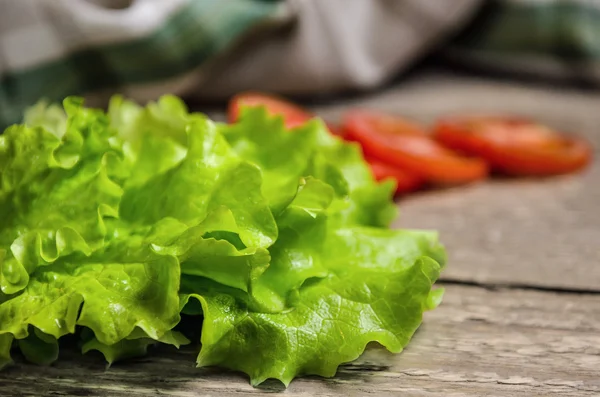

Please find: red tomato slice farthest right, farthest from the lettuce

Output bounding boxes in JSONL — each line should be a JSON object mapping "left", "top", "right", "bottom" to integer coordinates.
{"left": 434, "top": 117, "right": 592, "bottom": 176}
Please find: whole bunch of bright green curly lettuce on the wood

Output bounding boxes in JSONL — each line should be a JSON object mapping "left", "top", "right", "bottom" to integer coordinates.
{"left": 0, "top": 96, "right": 445, "bottom": 385}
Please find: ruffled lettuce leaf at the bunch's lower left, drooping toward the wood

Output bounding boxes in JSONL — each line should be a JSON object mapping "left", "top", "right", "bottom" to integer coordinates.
{"left": 0, "top": 241, "right": 180, "bottom": 356}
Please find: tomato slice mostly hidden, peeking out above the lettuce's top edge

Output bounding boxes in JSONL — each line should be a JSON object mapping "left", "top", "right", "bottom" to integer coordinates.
{"left": 228, "top": 92, "right": 314, "bottom": 128}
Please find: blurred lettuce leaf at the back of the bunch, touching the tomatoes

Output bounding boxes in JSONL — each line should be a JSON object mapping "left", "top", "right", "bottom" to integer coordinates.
{"left": 219, "top": 107, "right": 396, "bottom": 226}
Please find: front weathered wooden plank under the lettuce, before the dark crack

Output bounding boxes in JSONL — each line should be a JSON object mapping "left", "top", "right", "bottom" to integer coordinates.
{"left": 0, "top": 285, "right": 600, "bottom": 397}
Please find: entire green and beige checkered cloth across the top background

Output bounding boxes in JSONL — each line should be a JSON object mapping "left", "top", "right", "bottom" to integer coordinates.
{"left": 0, "top": 0, "right": 600, "bottom": 127}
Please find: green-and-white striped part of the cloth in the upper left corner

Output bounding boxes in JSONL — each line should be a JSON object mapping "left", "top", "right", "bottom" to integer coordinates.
{"left": 0, "top": 0, "right": 277, "bottom": 127}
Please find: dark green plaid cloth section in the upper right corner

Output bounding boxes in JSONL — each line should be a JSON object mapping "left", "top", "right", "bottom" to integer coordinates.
{"left": 444, "top": 0, "right": 600, "bottom": 84}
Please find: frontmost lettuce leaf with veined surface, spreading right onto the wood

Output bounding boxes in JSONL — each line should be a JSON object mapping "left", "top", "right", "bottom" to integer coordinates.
{"left": 195, "top": 229, "right": 443, "bottom": 385}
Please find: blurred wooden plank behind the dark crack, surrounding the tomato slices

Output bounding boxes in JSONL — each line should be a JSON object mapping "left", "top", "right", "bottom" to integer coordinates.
{"left": 314, "top": 74, "right": 600, "bottom": 290}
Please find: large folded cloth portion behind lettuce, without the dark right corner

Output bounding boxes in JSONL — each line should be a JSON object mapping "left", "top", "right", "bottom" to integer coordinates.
{"left": 0, "top": 0, "right": 477, "bottom": 127}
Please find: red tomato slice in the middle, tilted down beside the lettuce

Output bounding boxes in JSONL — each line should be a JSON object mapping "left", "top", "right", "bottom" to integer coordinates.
{"left": 343, "top": 110, "right": 487, "bottom": 184}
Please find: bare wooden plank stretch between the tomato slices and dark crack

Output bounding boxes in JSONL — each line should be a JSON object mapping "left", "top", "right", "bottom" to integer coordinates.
{"left": 396, "top": 164, "right": 600, "bottom": 289}
